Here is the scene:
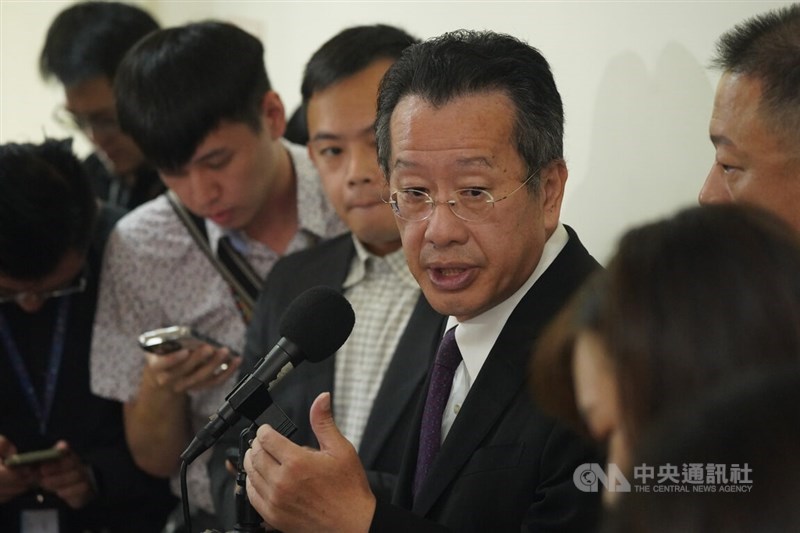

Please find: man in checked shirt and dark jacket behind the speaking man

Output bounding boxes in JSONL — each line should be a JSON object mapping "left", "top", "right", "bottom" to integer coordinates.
{"left": 209, "top": 25, "right": 444, "bottom": 526}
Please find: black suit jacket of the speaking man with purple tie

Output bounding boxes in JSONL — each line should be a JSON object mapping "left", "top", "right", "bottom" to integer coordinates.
{"left": 371, "top": 228, "right": 599, "bottom": 532}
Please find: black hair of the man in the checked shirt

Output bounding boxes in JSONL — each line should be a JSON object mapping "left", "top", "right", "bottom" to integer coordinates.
{"left": 300, "top": 24, "right": 419, "bottom": 107}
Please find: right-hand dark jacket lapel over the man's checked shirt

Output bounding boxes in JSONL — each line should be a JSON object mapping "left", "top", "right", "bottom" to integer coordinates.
{"left": 359, "top": 295, "right": 444, "bottom": 465}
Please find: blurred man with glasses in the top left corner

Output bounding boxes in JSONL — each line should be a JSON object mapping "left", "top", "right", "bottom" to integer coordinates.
{"left": 39, "top": 2, "right": 164, "bottom": 209}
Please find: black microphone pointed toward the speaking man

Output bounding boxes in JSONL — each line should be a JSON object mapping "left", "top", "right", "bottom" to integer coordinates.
{"left": 181, "top": 286, "right": 355, "bottom": 464}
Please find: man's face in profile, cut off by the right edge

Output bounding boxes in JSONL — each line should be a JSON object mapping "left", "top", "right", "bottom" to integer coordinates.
{"left": 699, "top": 4, "right": 800, "bottom": 231}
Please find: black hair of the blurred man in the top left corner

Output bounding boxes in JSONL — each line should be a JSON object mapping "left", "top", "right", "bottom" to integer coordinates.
{"left": 39, "top": 2, "right": 158, "bottom": 86}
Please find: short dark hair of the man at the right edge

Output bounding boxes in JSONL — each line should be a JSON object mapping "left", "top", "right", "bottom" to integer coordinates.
{"left": 712, "top": 4, "right": 800, "bottom": 145}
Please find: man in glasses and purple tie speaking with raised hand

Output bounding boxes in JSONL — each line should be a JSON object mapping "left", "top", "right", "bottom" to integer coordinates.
{"left": 245, "top": 31, "right": 599, "bottom": 532}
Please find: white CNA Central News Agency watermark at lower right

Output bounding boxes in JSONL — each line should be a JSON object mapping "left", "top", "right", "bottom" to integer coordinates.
{"left": 572, "top": 463, "right": 753, "bottom": 492}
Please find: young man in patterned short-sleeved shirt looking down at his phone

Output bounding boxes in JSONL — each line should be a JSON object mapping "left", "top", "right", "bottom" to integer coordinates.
{"left": 92, "top": 21, "right": 344, "bottom": 529}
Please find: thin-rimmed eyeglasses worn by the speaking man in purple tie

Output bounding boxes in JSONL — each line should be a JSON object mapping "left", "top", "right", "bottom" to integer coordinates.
{"left": 387, "top": 170, "right": 539, "bottom": 222}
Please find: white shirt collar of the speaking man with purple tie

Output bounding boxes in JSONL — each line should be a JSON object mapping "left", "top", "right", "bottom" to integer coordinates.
{"left": 445, "top": 224, "right": 569, "bottom": 384}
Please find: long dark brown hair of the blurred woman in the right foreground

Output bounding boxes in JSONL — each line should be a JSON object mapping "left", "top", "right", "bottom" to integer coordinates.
{"left": 532, "top": 204, "right": 800, "bottom": 446}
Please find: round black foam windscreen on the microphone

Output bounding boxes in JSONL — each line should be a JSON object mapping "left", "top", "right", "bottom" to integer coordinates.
{"left": 279, "top": 286, "right": 356, "bottom": 362}
